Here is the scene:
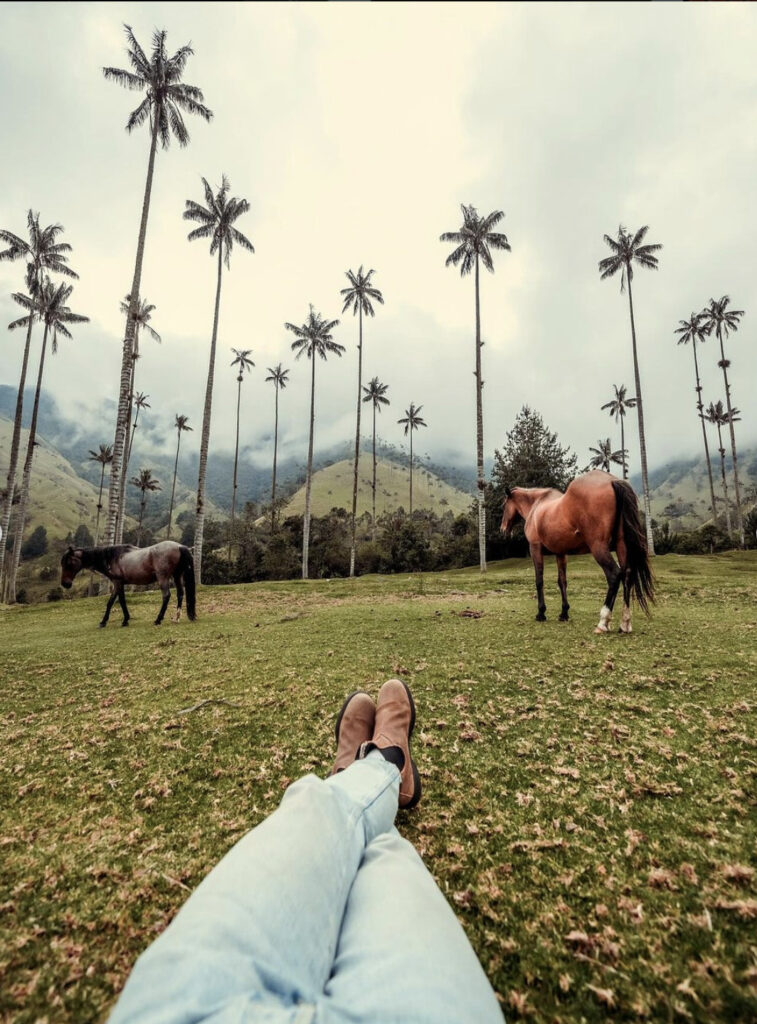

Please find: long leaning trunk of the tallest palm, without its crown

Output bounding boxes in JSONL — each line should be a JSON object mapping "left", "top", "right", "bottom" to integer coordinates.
{"left": 106, "top": 118, "right": 158, "bottom": 544}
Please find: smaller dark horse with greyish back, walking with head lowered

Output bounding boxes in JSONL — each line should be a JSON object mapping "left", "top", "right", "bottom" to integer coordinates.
{"left": 60, "top": 541, "right": 195, "bottom": 629}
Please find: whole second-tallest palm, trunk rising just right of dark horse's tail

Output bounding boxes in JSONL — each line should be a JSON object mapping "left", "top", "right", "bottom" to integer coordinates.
{"left": 183, "top": 174, "right": 255, "bottom": 583}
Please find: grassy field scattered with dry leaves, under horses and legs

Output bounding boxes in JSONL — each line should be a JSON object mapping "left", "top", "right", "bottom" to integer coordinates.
{"left": 0, "top": 552, "right": 757, "bottom": 1024}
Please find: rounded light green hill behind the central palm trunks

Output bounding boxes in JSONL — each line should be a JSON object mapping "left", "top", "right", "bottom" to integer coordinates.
{"left": 283, "top": 453, "right": 472, "bottom": 516}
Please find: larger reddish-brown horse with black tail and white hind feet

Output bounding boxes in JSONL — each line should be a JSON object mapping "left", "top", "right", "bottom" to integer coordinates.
{"left": 500, "top": 470, "right": 655, "bottom": 633}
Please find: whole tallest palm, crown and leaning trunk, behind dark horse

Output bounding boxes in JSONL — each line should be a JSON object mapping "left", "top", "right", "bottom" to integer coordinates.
{"left": 102, "top": 25, "right": 213, "bottom": 542}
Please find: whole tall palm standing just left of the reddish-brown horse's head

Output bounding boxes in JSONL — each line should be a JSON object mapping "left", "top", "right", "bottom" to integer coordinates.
{"left": 440, "top": 204, "right": 511, "bottom": 572}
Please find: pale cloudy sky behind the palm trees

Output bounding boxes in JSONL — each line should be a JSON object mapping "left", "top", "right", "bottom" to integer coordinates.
{"left": 0, "top": 3, "right": 757, "bottom": 485}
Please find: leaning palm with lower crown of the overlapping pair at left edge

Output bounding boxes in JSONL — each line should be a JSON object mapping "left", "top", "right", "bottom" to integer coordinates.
{"left": 6, "top": 278, "right": 89, "bottom": 604}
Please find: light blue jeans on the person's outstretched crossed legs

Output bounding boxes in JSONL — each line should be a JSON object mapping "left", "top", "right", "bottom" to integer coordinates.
{"left": 110, "top": 751, "right": 503, "bottom": 1024}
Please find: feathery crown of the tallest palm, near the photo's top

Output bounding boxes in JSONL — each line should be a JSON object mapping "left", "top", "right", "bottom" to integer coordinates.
{"left": 102, "top": 25, "right": 213, "bottom": 150}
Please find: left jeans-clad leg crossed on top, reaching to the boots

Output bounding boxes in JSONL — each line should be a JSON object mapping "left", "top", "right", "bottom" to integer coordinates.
{"left": 111, "top": 751, "right": 399, "bottom": 1024}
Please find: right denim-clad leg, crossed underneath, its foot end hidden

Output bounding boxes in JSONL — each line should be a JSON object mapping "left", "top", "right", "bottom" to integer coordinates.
{"left": 318, "top": 828, "right": 503, "bottom": 1024}
